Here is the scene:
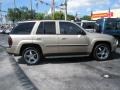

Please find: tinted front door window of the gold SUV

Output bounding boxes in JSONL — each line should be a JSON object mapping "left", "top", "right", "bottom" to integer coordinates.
{"left": 60, "top": 22, "right": 81, "bottom": 35}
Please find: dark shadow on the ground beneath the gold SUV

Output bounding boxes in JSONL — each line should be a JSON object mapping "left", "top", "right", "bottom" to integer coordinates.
{"left": 18, "top": 53, "right": 120, "bottom": 65}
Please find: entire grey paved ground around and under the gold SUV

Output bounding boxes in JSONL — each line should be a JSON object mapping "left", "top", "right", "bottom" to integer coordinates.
{"left": 0, "top": 34, "right": 120, "bottom": 90}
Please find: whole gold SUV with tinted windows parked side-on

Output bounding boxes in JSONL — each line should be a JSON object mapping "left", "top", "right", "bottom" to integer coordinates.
{"left": 7, "top": 20, "right": 117, "bottom": 65}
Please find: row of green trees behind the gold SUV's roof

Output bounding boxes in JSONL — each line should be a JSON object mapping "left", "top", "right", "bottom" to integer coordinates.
{"left": 8, "top": 7, "right": 74, "bottom": 21}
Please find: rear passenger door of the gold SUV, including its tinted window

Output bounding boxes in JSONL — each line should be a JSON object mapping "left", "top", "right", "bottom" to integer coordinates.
{"left": 34, "top": 21, "right": 58, "bottom": 55}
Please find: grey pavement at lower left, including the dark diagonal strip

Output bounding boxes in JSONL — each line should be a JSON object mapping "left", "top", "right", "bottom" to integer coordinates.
{"left": 0, "top": 34, "right": 38, "bottom": 90}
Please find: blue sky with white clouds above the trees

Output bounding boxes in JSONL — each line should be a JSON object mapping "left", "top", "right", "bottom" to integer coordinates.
{"left": 0, "top": 0, "right": 120, "bottom": 16}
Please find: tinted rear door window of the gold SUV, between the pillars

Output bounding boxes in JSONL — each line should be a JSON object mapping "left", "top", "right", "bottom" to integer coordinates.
{"left": 36, "top": 22, "right": 56, "bottom": 34}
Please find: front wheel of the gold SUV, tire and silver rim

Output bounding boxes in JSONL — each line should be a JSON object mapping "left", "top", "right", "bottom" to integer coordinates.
{"left": 93, "top": 43, "right": 111, "bottom": 61}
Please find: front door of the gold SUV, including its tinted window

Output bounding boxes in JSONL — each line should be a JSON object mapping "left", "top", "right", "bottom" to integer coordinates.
{"left": 59, "top": 22, "right": 89, "bottom": 54}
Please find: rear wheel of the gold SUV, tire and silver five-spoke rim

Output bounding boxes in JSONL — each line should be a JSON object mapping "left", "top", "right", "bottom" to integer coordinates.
{"left": 22, "top": 47, "right": 41, "bottom": 65}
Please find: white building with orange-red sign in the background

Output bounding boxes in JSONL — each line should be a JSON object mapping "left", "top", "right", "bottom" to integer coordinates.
{"left": 91, "top": 9, "right": 120, "bottom": 20}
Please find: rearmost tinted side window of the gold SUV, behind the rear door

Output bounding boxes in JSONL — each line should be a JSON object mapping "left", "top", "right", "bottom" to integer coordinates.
{"left": 11, "top": 22, "right": 35, "bottom": 34}
